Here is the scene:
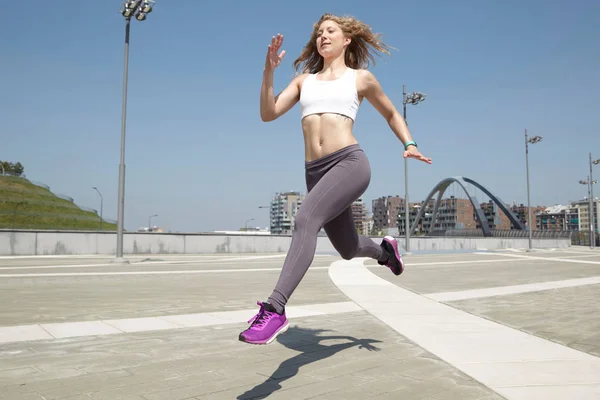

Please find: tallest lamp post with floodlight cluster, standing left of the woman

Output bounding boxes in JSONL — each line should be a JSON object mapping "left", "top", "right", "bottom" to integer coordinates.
{"left": 114, "top": 0, "right": 155, "bottom": 263}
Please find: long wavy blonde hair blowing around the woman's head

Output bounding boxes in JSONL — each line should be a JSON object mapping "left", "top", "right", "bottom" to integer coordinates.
{"left": 293, "top": 14, "right": 390, "bottom": 74}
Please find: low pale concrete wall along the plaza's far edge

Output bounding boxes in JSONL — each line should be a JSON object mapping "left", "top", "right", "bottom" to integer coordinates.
{"left": 0, "top": 230, "right": 571, "bottom": 255}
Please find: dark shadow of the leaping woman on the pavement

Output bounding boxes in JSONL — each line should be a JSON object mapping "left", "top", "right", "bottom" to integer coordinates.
{"left": 237, "top": 327, "right": 381, "bottom": 400}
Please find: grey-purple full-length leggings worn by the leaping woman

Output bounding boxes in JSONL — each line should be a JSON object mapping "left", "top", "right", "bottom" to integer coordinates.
{"left": 268, "top": 144, "right": 387, "bottom": 313}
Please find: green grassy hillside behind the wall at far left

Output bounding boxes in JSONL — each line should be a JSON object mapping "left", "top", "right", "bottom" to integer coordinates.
{"left": 0, "top": 176, "right": 117, "bottom": 231}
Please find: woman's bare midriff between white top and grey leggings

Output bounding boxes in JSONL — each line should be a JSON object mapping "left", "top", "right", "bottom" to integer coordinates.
{"left": 302, "top": 113, "right": 358, "bottom": 161}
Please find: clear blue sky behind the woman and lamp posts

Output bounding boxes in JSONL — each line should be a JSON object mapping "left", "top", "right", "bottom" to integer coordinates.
{"left": 0, "top": 0, "right": 600, "bottom": 231}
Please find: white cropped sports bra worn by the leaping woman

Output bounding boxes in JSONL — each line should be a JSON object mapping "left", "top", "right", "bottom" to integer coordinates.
{"left": 300, "top": 68, "right": 360, "bottom": 121}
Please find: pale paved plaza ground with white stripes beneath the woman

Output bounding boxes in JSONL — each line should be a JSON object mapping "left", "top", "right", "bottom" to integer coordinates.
{"left": 0, "top": 247, "right": 600, "bottom": 400}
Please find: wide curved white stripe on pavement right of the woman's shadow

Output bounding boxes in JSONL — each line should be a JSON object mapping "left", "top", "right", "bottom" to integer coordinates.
{"left": 329, "top": 259, "right": 600, "bottom": 400}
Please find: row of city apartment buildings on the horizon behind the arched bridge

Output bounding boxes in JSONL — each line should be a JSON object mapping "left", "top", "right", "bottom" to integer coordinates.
{"left": 260, "top": 191, "right": 600, "bottom": 235}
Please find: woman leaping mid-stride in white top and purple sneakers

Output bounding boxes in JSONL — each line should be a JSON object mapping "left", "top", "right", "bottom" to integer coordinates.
{"left": 239, "top": 14, "right": 431, "bottom": 344}
